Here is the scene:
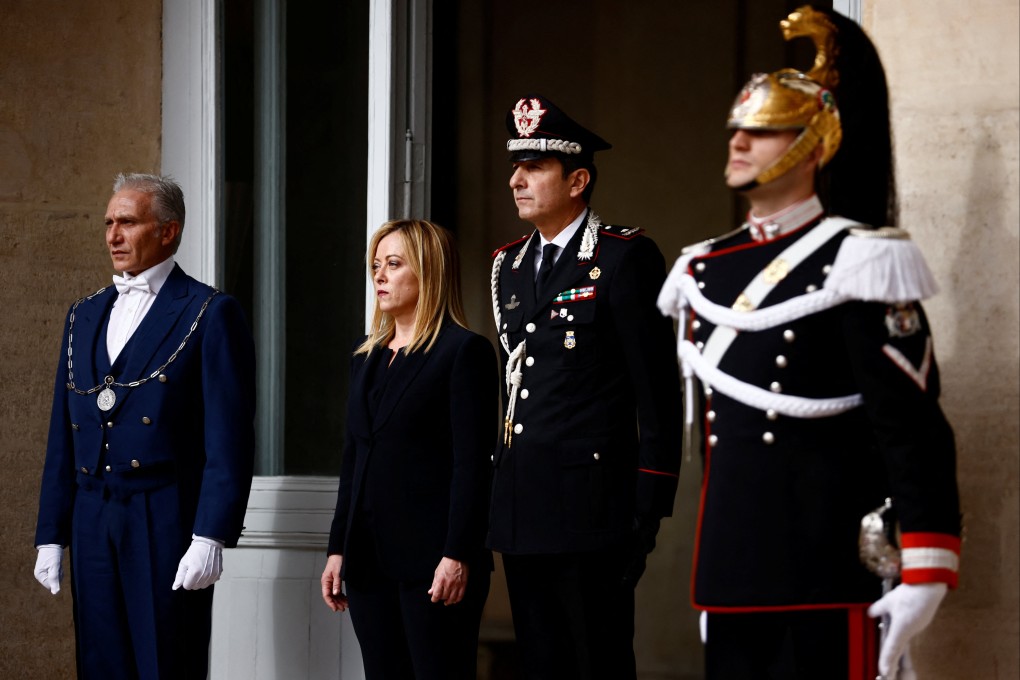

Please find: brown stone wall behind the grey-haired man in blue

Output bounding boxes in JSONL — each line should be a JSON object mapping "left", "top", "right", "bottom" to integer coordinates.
{"left": 0, "top": 0, "right": 161, "bottom": 680}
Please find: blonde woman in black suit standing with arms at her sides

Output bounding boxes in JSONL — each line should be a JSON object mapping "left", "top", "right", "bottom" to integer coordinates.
{"left": 321, "top": 219, "right": 498, "bottom": 680}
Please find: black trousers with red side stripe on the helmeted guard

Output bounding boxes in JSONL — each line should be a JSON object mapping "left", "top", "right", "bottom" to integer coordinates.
{"left": 705, "top": 608, "right": 878, "bottom": 680}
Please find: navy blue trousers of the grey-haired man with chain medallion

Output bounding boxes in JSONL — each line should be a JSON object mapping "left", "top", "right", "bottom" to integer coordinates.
{"left": 70, "top": 480, "right": 213, "bottom": 680}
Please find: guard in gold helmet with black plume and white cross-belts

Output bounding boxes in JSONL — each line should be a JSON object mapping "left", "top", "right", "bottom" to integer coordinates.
{"left": 659, "top": 7, "right": 961, "bottom": 680}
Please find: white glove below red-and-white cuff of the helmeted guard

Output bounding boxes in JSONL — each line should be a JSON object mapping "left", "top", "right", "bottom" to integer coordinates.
{"left": 868, "top": 583, "right": 949, "bottom": 680}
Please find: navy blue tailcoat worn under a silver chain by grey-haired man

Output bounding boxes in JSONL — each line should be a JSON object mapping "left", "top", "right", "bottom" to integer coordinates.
{"left": 36, "top": 265, "right": 255, "bottom": 547}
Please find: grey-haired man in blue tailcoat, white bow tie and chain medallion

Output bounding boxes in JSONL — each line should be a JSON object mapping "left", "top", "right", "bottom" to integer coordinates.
{"left": 35, "top": 174, "right": 255, "bottom": 680}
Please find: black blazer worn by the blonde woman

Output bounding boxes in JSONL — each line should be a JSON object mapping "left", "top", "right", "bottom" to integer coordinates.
{"left": 328, "top": 323, "right": 499, "bottom": 580}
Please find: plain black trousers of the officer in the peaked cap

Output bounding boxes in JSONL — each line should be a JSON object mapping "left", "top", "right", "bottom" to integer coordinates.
{"left": 503, "top": 548, "right": 636, "bottom": 680}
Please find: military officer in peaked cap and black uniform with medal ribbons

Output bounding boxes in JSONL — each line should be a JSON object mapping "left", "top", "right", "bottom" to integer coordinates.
{"left": 488, "top": 95, "right": 681, "bottom": 680}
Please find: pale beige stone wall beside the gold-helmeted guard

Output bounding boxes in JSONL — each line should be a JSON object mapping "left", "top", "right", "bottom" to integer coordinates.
{"left": 864, "top": 0, "right": 1020, "bottom": 680}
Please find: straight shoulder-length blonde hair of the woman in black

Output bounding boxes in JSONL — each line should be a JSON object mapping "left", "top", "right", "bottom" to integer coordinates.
{"left": 354, "top": 219, "right": 467, "bottom": 354}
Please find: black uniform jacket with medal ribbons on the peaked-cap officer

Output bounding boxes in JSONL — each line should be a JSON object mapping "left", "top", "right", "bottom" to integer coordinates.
{"left": 488, "top": 212, "right": 681, "bottom": 554}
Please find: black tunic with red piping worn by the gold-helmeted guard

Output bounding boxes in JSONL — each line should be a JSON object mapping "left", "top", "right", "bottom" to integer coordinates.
{"left": 690, "top": 219, "right": 960, "bottom": 611}
